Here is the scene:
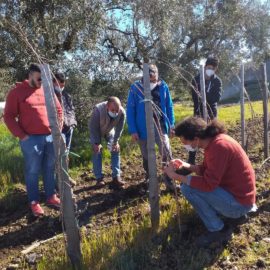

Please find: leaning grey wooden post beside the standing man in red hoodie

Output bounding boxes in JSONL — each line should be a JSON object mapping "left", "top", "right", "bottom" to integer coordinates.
{"left": 41, "top": 64, "right": 81, "bottom": 269}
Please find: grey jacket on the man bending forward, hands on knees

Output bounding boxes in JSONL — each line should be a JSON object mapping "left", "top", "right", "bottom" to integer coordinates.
{"left": 88, "top": 101, "right": 126, "bottom": 144}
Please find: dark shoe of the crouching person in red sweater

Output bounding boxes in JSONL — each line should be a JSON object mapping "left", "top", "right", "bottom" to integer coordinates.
{"left": 196, "top": 225, "right": 232, "bottom": 248}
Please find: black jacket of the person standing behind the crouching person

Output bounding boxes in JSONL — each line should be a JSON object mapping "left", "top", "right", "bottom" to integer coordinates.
{"left": 192, "top": 74, "right": 222, "bottom": 119}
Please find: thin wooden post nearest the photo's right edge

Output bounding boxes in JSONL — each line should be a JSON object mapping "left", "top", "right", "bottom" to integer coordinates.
{"left": 262, "top": 63, "right": 269, "bottom": 159}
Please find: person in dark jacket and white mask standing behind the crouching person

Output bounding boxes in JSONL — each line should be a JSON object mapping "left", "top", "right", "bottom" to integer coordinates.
{"left": 186, "top": 57, "right": 222, "bottom": 167}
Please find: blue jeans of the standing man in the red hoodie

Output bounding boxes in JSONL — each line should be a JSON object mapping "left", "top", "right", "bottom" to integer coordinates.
{"left": 20, "top": 135, "right": 55, "bottom": 202}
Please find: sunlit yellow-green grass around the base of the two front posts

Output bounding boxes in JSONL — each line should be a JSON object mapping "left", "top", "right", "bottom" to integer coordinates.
{"left": 37, "top": 195, "right": 204, "bottom": 270}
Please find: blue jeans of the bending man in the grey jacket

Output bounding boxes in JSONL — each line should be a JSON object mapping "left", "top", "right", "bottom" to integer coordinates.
{"left": 92, "top": 134, "right": 121, "bottom": 179}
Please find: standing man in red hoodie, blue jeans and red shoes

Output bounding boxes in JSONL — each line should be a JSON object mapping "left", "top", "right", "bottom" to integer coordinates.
{"left": 4, "top": 64, "right": 62, "bottom": 216}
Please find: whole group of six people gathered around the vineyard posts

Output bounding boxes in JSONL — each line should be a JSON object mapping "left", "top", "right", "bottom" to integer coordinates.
{"left": 4, "top": 57, "right": 256, "bottom": 246}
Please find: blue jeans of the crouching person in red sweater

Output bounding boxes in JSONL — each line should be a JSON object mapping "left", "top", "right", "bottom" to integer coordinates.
{"left": 181, "top": 184, "right": 253, "bottom": 232}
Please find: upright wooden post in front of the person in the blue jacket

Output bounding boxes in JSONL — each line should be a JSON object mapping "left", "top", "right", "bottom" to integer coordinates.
{"left": 143, "top": 63, "right": 159, "bottom": 230}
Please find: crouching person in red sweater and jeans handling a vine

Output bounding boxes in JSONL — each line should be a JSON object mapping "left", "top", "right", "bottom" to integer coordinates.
{"left": 165, "top": 117, "right": 256, "bottom": 247}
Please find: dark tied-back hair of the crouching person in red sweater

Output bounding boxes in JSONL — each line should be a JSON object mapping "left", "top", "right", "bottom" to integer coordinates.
{"left": 175, "top": 117, "right": 226, "bottom": 141}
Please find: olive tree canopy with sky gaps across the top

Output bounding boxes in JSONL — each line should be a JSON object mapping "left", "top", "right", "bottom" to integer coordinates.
{"left": 0, "top": 0, "right": 270, "bottom": 103}
